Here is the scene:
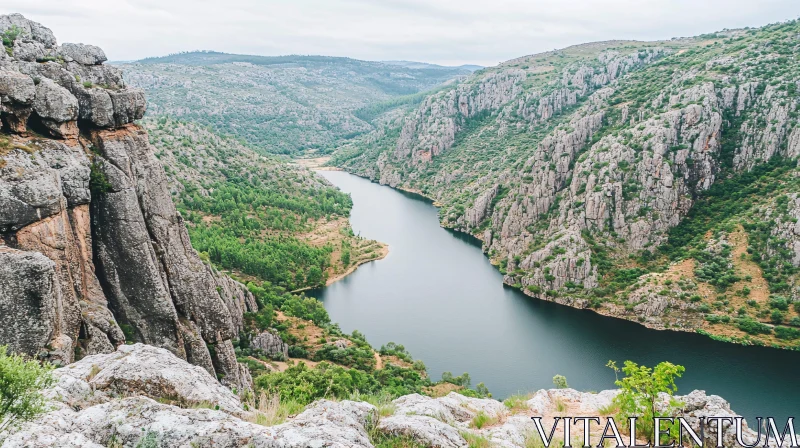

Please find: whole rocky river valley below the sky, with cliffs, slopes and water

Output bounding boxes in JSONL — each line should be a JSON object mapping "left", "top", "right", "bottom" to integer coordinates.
{"left": 0, "top": 9, "right": 800, "bottom": 448}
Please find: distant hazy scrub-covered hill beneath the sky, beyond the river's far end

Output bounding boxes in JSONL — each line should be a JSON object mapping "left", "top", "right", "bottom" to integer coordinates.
{"left": 120, "top": 52, "right": 470, "bottom": 154}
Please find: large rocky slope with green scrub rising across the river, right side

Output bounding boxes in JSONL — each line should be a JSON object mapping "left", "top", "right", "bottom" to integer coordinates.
{"left": 332, "top": 21, "right": 800, "bottom": 348}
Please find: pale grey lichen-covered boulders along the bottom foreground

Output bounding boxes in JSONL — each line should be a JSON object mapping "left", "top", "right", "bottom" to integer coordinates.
{"left": 0, "top": 344, "right": 788, "bottom": 448}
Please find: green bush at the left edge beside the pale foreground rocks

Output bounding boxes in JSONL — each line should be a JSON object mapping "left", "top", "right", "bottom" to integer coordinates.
{"left": 0, "top": 346, "right": 53, "bottom": 433}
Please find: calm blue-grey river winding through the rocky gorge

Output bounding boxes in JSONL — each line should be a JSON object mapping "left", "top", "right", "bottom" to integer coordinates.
{"left": 313, "top": 171, "right": 800, "bottom": 427}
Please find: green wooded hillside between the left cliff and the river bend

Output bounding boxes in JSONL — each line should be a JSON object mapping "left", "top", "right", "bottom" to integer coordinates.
{"left": 144, "top": 117, "right": 384, "bottom": 290}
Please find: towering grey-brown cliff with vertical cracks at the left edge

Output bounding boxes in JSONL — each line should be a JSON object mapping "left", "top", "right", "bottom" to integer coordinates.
{"left": 0, "top": 14, "right": 257, "bottom": 387}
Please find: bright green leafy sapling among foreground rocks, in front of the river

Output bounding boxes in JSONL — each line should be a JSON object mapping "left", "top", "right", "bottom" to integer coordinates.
{"left": 606, "top": 361, "right": 686, "bottom": 441}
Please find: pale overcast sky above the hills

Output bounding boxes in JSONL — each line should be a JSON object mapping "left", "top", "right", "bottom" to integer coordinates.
{"left": 0, "top": 0, "right": 800, "bottom": 65}
